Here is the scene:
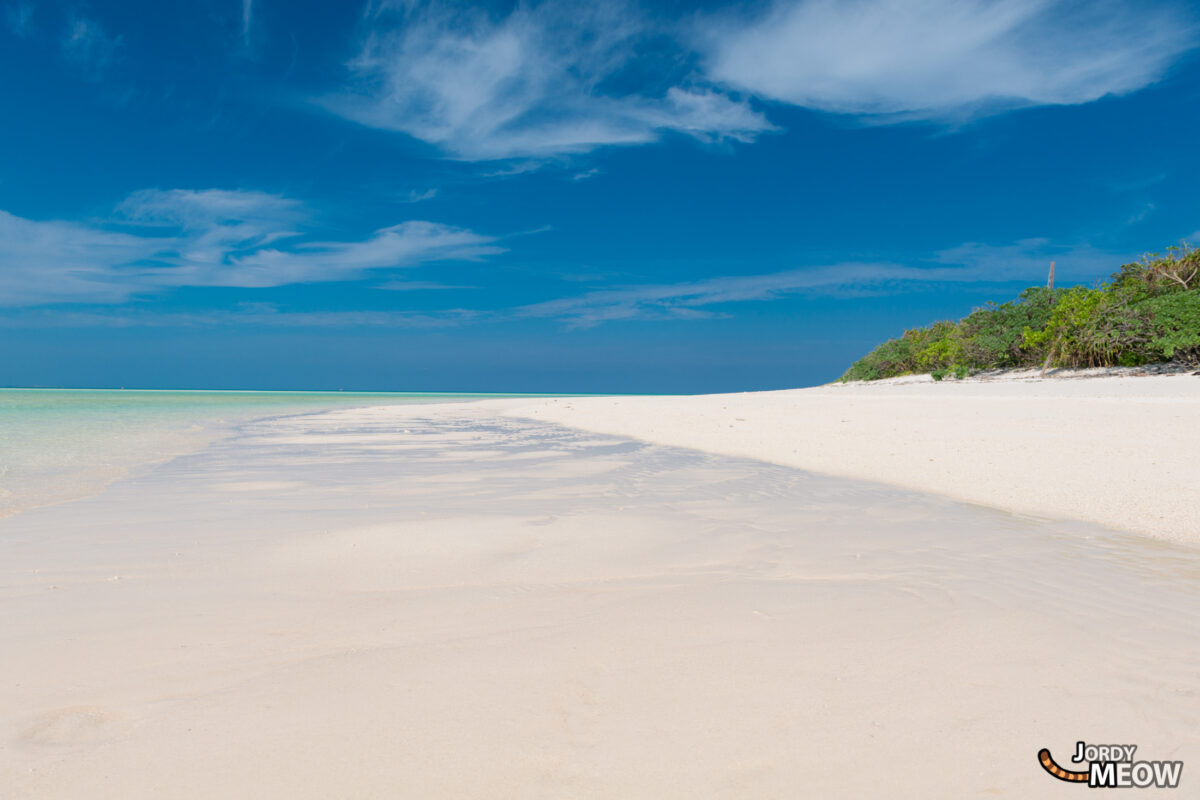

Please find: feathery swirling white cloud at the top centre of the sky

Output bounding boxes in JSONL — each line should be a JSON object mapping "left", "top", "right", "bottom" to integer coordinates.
{"left": 322, "top": 2, "right": 773, "bottom": 161}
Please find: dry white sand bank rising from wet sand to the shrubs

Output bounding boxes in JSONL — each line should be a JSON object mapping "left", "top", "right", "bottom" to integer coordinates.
{"left": 497, "top": 374, "right": 1200, "bottom": 543}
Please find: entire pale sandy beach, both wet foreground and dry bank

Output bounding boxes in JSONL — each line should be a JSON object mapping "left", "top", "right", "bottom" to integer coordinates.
{"left": 0, "top": 375, "right": 1200, "bottom": 798}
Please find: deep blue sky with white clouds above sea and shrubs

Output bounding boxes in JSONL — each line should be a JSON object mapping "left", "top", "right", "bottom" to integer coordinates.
{"left": 0, "top": 0, "right": 1200, "bottom": 392}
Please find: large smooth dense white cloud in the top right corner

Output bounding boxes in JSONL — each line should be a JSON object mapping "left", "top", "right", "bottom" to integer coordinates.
{"left": 698, "top": 0, "right": 1195, "bottom": 121}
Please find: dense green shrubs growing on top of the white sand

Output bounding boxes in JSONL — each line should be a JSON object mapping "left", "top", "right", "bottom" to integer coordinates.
{"left": 841, "top": 242, "right": 1200, "bottom": 380}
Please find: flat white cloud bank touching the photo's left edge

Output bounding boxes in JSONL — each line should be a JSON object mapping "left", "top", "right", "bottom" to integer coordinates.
{"left": 0, "top": 190, "right": 503, "bottom": 306}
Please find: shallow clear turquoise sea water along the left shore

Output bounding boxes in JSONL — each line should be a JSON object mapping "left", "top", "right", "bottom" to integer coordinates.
{"left": 0, "top": 389, "right": 544, "bottom": 517}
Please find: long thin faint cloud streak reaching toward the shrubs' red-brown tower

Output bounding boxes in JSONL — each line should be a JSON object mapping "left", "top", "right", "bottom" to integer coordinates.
{"left": 514, "top": 239, "right": 1120, "bottom": 327}
